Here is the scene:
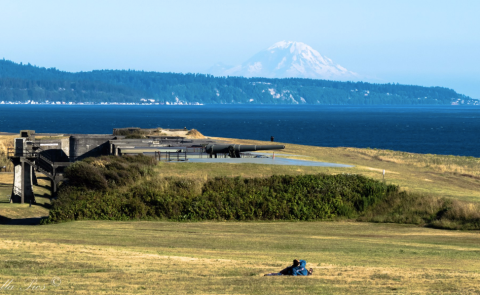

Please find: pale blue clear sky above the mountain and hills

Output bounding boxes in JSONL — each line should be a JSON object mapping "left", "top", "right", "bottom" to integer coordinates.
{"left": 0, "top": 0, "right": 480, "bottom": 99}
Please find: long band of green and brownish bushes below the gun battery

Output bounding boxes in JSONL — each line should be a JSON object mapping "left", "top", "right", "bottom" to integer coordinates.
{"left": 38, "top": 156, "right": 480, "bottom": 229}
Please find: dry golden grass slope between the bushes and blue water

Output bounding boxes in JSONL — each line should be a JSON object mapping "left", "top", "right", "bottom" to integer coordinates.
{"left": 210, "top": 138, "right": 480, "bottom": 202}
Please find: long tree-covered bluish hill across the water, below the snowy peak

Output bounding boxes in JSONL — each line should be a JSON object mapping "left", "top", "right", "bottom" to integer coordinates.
{"left": 0, "top": 59, "right": 479, "bottom": 105}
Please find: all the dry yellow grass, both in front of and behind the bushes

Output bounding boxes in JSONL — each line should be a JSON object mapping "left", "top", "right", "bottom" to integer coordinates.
{"left": 0, "top": 139, "right": 480, "bottom": 294}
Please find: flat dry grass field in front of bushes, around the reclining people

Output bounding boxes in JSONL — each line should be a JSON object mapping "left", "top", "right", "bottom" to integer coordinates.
{"left": 0, "top": 221, "right": 480, "bottom": 294}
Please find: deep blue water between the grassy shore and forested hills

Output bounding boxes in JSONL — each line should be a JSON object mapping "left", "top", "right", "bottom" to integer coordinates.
{"left": 0, "top": 105, "right": 480, "bottom": 157}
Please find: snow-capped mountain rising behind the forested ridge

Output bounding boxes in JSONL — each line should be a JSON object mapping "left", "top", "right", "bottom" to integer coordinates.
{"left": 209, "top": 41, "right": 359, "bottom": 81}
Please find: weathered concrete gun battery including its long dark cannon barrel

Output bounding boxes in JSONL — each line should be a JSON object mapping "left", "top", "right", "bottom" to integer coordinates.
{"left": 8, "top": 127, "right": 284, "bottom": 203}
